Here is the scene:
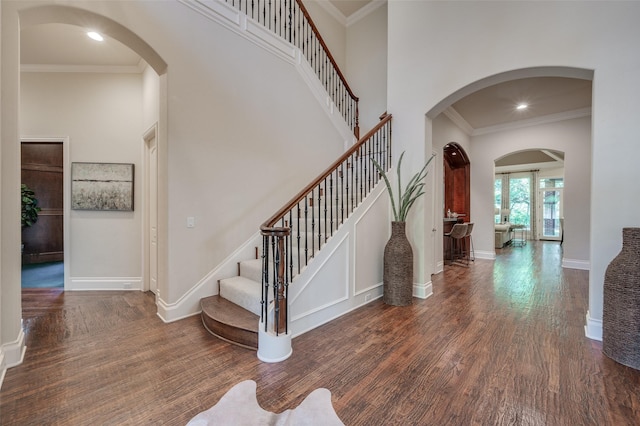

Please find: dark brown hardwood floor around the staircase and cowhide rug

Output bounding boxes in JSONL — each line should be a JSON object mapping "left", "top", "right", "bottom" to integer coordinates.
{"left": 0, "top": 243, "right": 640, "bottom": 426}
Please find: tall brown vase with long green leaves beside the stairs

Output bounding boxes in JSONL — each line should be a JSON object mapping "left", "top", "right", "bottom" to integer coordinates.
{"left": 372, "top": 152, "right": 434, "bottom": 306}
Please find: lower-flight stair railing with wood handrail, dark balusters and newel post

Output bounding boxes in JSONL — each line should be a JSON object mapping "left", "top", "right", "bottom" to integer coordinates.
{"left": 260, "top": 115, "right": 391, "bottom": 335}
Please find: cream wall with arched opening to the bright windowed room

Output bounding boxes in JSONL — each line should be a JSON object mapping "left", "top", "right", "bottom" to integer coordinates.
{"left": 471, "top": 117, "right": 591, "bottom": 269}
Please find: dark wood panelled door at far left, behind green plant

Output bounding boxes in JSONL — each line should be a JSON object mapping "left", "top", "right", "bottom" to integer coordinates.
{"left": 22, "top": 142, "right": 64, "bottom": 264}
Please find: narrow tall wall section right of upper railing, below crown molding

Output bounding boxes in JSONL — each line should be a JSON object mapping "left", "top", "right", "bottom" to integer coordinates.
{"left": 346, "top": 4, "right": 387, "bottom": 135}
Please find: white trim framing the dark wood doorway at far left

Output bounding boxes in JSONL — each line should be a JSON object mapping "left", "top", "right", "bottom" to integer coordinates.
{"left": 20, "top": 136, "right": 71, "bottom": 291}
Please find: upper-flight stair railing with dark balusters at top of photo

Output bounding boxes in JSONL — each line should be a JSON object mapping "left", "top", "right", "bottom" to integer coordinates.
{"left": 224, "top": 0, "right": 360, "bottom": 138}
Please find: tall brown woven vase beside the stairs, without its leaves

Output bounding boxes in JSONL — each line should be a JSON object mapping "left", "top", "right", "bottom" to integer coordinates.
{"left": 382, "top": 222, "right": 413, "bottom": 306}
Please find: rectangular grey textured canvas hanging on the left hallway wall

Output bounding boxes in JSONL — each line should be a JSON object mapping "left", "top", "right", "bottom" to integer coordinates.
{"left": 71, "top": 163, "right": 134, "bottom": 211}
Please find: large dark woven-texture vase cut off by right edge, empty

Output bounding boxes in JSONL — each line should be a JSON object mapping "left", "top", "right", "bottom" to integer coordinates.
{"left": 602, "top": 228, "right": 640, "bottom": 370}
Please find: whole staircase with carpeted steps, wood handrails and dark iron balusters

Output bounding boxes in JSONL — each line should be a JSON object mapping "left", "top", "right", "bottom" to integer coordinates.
{"left": 198, "top": 0, "right": 391, "bottom": 352}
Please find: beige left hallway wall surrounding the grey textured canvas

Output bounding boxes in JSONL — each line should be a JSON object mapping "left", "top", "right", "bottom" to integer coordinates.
{"left": 20, "top": 72, "right": 144, "bottom": 289}
